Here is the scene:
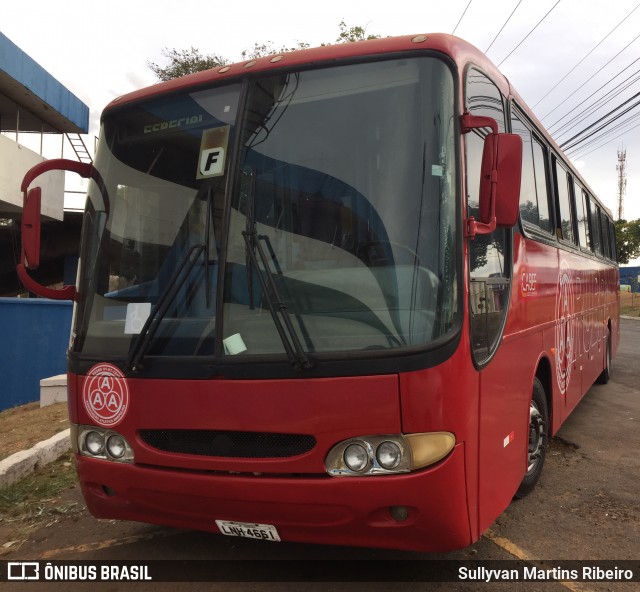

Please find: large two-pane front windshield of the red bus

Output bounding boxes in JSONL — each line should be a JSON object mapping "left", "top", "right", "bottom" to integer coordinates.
{"left": 72, "top": 57, "right": 459, "bottom": 359}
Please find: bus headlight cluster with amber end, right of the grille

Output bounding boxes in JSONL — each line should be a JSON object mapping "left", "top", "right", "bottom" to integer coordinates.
{"left": 325, "top": 432, "right": 456, "bottom": 477}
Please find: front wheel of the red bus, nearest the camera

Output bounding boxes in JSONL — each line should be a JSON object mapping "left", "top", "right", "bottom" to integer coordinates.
{"left": 516, "top": 377, "right": 549, "bottom": 498}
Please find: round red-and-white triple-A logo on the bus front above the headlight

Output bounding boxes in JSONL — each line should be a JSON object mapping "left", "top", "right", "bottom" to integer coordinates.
{"left": 82, "top": 364, "right": 129, "bottom": 427}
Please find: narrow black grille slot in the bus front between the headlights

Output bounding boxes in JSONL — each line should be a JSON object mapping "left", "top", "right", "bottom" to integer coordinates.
{"left": 140, "top": 430, "right": 316, "bottom": 458}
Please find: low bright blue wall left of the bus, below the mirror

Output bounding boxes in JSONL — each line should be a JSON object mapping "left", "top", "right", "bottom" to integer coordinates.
{"left": 0, "top": 298, "right": 73, "bottom": 411}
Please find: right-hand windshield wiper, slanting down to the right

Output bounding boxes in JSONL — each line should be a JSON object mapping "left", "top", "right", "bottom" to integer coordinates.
{"left": 242, "top": 229, "right": 313, "bottom": 370}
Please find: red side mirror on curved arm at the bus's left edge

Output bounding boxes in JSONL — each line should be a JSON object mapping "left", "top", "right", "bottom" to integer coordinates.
{"left": 16, "top": 158, "right": 93, "bottom": 300}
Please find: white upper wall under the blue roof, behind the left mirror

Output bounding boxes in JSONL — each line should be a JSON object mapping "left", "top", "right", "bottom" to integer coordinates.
{"left": 0, "top": 135, "right": 64, "bottom": 220}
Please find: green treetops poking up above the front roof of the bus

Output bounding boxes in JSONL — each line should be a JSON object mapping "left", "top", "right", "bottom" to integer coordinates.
{"left": 147, "top": 21, "right": 380, "bottom": 82}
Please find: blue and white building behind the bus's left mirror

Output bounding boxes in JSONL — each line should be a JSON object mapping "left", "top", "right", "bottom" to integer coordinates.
{"left": 0, "top": 33, "right": 90, "bottom": 410}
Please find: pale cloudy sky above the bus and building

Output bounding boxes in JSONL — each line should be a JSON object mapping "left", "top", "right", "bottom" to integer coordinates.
{"left": 0, "top": 0, "right": 640, "bottom": 236}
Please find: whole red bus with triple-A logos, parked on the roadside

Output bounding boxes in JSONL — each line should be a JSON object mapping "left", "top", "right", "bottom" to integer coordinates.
{"left": 19, "top": 34, "right": 619, "bottom": 551}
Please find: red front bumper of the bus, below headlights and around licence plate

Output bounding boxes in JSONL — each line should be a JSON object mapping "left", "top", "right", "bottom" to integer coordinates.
{"left": 76, "top": 444, "right": 473, "bottom": 552}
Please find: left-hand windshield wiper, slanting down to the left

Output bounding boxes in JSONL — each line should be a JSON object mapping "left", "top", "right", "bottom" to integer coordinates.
{"left": 127, "top": 243, "right": 209, "bottom": 372}
